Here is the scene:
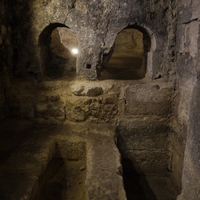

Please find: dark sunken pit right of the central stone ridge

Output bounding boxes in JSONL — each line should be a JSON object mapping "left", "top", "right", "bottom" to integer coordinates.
{"left": 116, "top": 124, "right": 178, "bottom": 200}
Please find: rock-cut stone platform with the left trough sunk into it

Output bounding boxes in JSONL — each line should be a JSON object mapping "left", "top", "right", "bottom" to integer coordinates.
{"left": 0, "top": 122, "right": 126, "bottom": 200}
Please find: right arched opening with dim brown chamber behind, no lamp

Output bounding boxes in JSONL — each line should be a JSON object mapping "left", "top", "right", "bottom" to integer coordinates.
{"left": 100, "top": 26, "right": 151, "bottom": 80}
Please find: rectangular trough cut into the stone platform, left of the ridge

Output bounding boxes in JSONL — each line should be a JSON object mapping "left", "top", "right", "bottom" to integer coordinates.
{"left": 34, "top": 141, "right": 88, "bottom": 200}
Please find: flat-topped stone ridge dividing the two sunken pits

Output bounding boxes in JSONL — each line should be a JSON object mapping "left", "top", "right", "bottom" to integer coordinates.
{"left": 86, "top": 127, "right": 126, "bottom": 200}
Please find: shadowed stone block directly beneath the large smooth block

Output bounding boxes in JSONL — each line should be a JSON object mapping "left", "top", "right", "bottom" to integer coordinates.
{"left": 118, "top": 118, "right": 169, "bottom": 151}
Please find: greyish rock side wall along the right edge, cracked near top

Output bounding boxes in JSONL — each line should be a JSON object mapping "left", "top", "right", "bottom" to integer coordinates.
{"left": 177, "top": 0, "right": 200, "bottom": 200}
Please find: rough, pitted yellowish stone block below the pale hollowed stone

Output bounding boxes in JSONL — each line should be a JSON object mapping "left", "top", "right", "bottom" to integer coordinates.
{"left": 66, "top": 94, "right": 118, "bottom": 123}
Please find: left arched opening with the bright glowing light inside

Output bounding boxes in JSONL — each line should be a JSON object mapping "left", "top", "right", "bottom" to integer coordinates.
{"left": 39, "top": 24, "right": 78, "bottom": 79}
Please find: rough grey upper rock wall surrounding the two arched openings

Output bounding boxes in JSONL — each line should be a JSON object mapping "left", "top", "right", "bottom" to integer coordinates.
{"left": 11, "top": 0, "right": 175, "bottom": 78}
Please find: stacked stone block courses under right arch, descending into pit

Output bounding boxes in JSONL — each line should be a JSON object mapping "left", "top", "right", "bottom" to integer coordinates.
{"left": 118, "top": 82, "right": 173, "bottom": 176}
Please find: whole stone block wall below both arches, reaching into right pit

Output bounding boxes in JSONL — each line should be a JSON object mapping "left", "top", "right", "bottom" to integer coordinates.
{"left": 3, "top": 78, "right": 173, "bottom": 184}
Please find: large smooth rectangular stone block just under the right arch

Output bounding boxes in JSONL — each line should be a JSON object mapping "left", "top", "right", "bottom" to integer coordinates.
{"left": 125, "top": 84, "right": 172, "bottom": 116}
